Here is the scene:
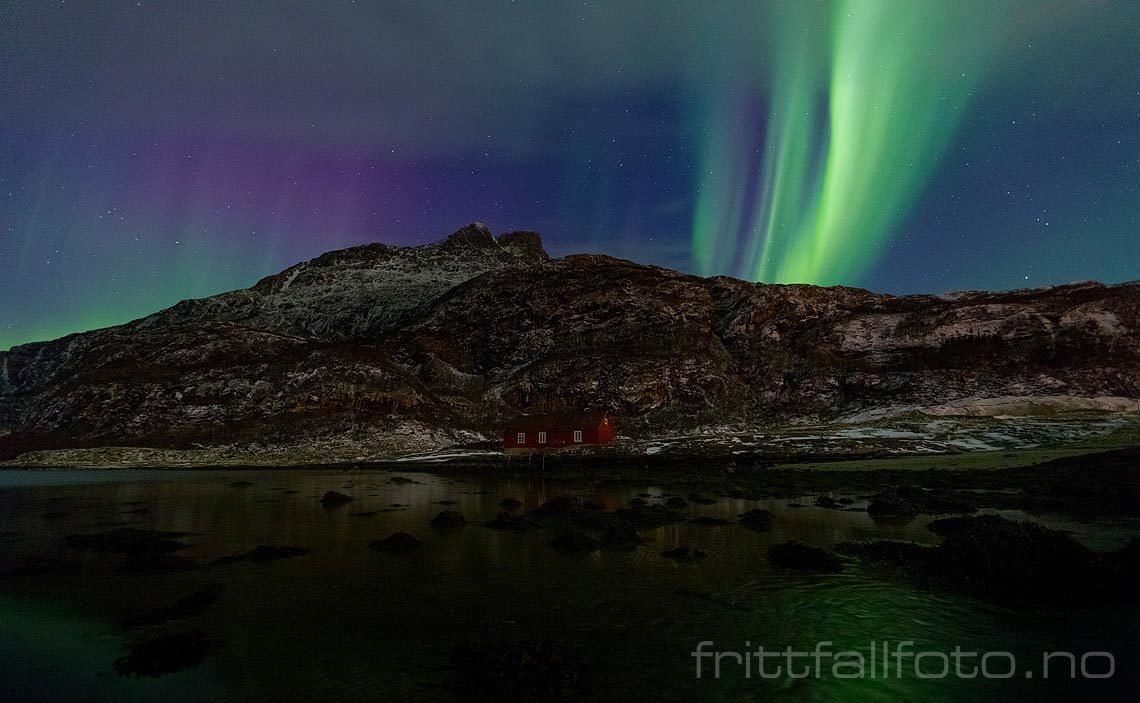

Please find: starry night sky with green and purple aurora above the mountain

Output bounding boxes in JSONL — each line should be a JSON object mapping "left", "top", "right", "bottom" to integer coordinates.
{"left": 0, "top": 0, "right": 1140, "bottom": 349}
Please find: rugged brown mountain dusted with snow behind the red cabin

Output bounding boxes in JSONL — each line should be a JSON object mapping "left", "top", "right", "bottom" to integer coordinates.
{"left": 0, "top": 226, "right": 1140, "bottom": 456}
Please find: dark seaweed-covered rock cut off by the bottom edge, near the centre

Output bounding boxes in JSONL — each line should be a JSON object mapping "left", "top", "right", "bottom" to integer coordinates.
{"left": 451, "top": 641, "right": 585, "bottom": 703}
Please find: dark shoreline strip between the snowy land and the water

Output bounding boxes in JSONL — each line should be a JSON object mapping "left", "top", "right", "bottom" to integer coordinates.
{"left": 0, "top": 444, "right": 1140, "bottom": 521}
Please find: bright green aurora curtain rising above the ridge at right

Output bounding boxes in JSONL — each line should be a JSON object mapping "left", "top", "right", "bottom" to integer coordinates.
{"left": 692, "top": 0, "right": 1001, "bottom": 285}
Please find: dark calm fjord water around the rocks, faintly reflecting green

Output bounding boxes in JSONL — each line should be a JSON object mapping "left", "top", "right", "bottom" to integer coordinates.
{"left": 0, "top": 471, "right": 1140, "bottom": 703}
